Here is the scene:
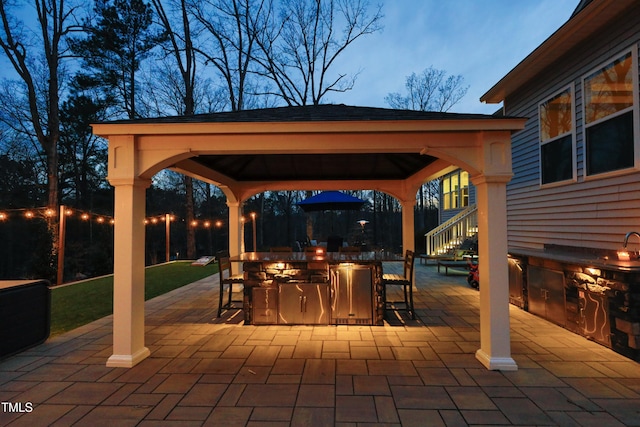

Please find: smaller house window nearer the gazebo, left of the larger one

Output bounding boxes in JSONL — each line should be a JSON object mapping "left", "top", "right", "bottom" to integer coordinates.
{"left": 539, "top": 88, "right": 575, "bottom": 184}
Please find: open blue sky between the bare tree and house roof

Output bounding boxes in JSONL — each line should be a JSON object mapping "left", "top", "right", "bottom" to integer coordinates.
{"left": 328, "top": 0, "right": 579, "bottom": 114}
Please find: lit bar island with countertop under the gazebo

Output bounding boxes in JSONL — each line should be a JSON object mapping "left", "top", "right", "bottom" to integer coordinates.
{"left": 231, "top": 251, "right": 402, "bottom": 325}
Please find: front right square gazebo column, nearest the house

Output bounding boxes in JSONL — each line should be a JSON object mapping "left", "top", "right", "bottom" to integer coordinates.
{"left": 472, "top": 174, "right": 518, "bottom": 371}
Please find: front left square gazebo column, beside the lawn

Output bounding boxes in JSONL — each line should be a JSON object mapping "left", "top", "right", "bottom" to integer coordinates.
{"left": 107, "top": 178, "right": 151, "bottom": 368}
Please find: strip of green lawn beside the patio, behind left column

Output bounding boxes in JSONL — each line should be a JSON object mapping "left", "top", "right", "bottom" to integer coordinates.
{"left": 51, "top": 261, "right": 218, "bottom": 337}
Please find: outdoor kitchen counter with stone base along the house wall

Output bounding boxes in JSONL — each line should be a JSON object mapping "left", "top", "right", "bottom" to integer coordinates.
{"left": 509, "top": 246, "right": 640, "bottom": 361}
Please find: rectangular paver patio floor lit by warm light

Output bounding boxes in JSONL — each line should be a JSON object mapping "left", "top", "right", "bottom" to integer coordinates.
{"left": 0, "top": 264, "right": 640, "bottom": 427}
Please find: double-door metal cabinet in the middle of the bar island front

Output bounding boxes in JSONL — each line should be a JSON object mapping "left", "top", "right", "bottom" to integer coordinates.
{"left": 278, "top": 283, "right": 330, "bottom": 325}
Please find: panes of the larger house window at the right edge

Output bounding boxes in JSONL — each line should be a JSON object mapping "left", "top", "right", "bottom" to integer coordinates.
{"left": 584, "top": 52, "right": 637, "bottom": 175}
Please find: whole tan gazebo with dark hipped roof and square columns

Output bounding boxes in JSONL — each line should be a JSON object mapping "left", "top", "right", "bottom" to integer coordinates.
{"left": 93, "top": 105, "right": 526, "bottom": 370}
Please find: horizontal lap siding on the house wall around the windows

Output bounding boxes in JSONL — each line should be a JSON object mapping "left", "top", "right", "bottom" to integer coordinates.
{"left": 504, "top": 2, "right": 640, "bottom": 250}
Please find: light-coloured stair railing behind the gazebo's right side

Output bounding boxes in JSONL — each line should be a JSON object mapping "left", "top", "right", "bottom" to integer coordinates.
{"left": 425, "top": 205, "right": 478, "bottom": 255}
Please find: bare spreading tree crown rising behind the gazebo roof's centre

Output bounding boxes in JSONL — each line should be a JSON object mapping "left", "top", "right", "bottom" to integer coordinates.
{"left": 256, "top": 0, "right": 383, "bottom": 105}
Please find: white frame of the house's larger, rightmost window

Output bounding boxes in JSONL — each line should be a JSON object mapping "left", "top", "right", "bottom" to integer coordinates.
{"left": 581, "top": 44, "right": 640, "bottom": 181}
